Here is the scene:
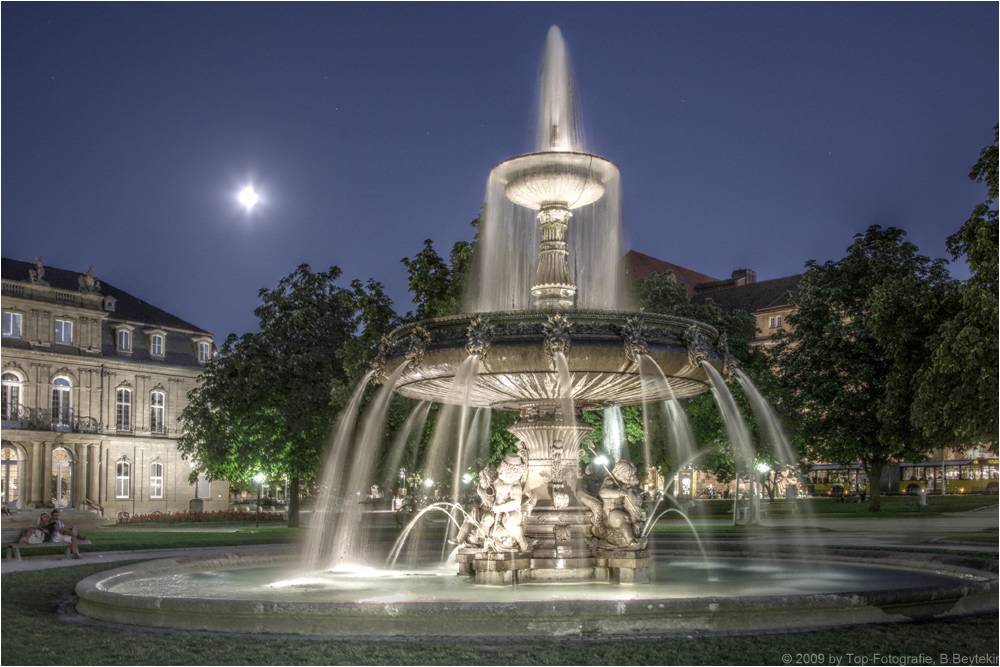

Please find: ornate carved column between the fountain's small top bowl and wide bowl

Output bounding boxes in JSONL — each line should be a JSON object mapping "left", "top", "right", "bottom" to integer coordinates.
{"left": 531, "top": 204, "right": 576, "bottom": 310}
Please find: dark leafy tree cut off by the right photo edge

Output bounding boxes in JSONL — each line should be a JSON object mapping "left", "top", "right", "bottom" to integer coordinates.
{"left": 912, "top": 128, "right": 1000, "bottom": 451}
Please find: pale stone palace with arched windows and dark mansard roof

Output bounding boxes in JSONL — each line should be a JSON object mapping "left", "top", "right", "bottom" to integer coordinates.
{"left": 2, "top": 258, "right": 229, "bottom": 517}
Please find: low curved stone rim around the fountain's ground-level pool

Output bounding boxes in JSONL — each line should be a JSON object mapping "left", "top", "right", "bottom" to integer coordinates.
{"left": 76, "top": 548, "right": 1000, "bottom": 638}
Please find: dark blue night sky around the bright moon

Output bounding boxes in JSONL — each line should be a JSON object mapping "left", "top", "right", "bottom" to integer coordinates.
{"left": 2, "top": 2, "right": 998, "bottom": 338}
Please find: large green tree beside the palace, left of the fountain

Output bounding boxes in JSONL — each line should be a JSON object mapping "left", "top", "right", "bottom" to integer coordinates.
{"left": 178, "top": 264, "right": 396, "bottom": 526}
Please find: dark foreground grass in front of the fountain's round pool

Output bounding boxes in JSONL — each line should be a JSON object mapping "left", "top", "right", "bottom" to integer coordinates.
{"left": 0, "top": 563, "right": 1000, "bottom": 665}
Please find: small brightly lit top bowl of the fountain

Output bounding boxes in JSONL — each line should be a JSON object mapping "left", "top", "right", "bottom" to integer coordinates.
{"left": 493, "top": 152, "right": 618, "bottom": 211}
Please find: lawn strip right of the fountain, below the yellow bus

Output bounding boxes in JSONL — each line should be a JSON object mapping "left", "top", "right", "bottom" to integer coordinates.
{"left": 676, "top": 495, "right": 997, "bottom": 521}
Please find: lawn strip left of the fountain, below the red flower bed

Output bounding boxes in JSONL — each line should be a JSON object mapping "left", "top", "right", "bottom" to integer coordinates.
{"left": 10, "top": 523, "right": 302, "bottom": 558}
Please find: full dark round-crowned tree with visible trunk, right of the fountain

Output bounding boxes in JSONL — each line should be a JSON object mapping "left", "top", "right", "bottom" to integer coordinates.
{"left": 773, "top": 225, "right": 955, "bottom": 511}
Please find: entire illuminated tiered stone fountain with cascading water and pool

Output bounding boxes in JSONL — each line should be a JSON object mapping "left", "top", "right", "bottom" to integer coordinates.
{"left": 77, "top": 27, "right": 996, "bottom": 637}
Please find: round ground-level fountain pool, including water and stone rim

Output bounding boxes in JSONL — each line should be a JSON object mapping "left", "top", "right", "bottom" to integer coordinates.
{"left": 77, "top": 550, "right": 997, "bottom": 637}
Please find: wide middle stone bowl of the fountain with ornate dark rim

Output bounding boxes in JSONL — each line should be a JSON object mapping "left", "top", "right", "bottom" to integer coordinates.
{"left": 385, "top": 311, "right": 725, "bottom": 409}
